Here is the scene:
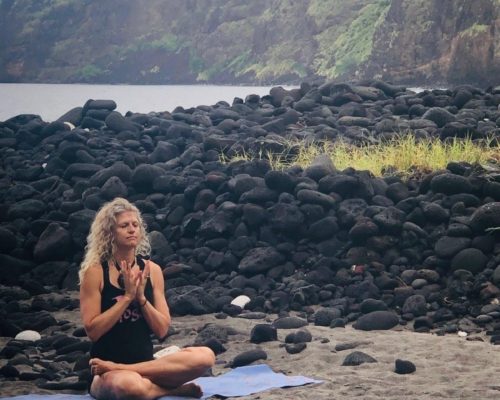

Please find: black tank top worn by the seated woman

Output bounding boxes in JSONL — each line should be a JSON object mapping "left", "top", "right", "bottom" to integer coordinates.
{"left": 90, "top": 257, "right": 153, "bottom": 364}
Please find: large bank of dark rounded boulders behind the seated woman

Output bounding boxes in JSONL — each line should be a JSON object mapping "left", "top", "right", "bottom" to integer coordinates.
{"left": 0, "top": 81, "right": 500, "bottom": 390}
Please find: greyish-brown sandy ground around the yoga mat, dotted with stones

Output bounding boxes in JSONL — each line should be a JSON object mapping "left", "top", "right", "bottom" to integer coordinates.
{"left": 0, "top": 298, "right": 500, "bottom": 400}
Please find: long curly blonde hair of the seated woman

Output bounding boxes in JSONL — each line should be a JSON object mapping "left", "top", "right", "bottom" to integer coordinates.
{"left": 78, "top": 197, "right": 151, "bottom": 283}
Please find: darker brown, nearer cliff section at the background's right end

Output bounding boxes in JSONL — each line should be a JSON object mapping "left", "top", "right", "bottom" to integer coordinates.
{"left": 363, "top": 0, "right": 500, "bottom": 84}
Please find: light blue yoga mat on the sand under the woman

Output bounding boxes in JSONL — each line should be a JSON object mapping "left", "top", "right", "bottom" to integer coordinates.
{"left": 0, "top": 364, "right": 323, "bottom": 400}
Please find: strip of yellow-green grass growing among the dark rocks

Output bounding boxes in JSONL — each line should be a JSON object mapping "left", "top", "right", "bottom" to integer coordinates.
{"left": 221, "top": 134, "right": 500, "bottom": 176}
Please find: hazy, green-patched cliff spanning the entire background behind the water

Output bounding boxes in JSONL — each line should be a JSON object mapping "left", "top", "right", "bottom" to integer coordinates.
{"left": 0, "top": 0, "right": 500, "bottom": 84}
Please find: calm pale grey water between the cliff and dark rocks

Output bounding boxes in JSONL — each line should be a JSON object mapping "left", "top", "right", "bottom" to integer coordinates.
{"left": 0, "top": 83, "right": 290, "bottom": 122}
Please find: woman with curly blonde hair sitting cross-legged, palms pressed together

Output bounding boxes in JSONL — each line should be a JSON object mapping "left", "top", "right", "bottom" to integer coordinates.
{"left": 79, "top": 198, "right": 215, "bottom": 400}
